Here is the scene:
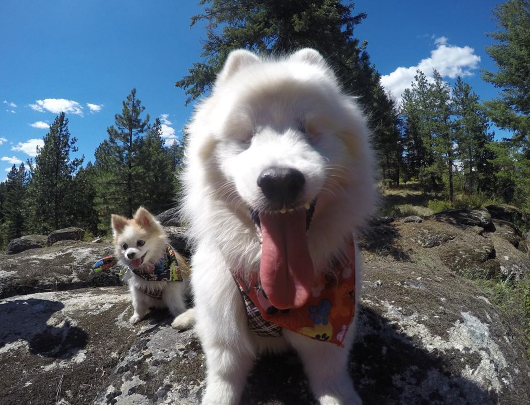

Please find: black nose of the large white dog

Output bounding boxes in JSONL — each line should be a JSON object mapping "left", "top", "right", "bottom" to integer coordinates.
{"left": 258, "top": 167, "right": 305, "bottom": 209}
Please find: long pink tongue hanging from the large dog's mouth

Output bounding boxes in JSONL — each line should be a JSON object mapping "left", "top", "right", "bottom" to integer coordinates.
{"left": 259, "top": 210, "right": 314, "bottom": 309}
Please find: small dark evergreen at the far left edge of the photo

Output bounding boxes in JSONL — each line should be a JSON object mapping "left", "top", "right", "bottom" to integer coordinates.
{"left": 2, "top": 163, "right": 28, "bottom": 243}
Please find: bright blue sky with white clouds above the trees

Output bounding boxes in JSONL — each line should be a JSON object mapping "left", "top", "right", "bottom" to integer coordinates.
{"left": 0, "top": 0, "right": 507, "bottom": 178}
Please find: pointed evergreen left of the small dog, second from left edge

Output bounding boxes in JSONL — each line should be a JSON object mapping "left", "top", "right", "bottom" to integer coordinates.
{"left": 29, "top": 113, "right": 84, "bottom": 233}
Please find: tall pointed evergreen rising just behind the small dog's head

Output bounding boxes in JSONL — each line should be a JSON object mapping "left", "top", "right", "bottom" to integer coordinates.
{"left": 94, "top": 89, "right": 149, "bottom": 231}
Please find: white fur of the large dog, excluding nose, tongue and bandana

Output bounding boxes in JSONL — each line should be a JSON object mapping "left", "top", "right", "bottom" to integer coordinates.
{"left": 182, "top": 49, "right": 374, "bottom": 404}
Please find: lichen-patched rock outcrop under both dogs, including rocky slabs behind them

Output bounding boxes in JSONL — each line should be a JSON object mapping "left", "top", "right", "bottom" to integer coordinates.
{"left": 0, "top": 210, "right": 530, "bottom": 405}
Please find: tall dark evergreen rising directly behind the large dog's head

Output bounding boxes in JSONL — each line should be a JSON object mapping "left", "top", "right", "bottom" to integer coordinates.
{"left": 176, "top": 0, "right": 401, "bottom": 174}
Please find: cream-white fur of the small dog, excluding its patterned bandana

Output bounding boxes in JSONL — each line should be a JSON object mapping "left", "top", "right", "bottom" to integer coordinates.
{"left": 112, "top": 208, "right": 194, "bottom": 330}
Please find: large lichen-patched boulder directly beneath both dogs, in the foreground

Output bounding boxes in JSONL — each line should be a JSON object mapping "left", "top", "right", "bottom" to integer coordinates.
{"left": 0, "top": 274, "right": 530, "bottom": 405}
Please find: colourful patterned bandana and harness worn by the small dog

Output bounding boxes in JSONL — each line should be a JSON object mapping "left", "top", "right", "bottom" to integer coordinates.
{"left": 92, "top": 244, "right": 184, "bottom": 299}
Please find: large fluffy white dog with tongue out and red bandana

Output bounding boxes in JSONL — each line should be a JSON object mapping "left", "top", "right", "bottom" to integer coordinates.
{"left": 182, "top": 49, "right": 374, "bottom": 404}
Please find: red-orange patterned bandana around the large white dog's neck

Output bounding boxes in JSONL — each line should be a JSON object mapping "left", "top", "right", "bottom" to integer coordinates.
{"left": 234, "top": 240, "right": 355, "bottom": 347}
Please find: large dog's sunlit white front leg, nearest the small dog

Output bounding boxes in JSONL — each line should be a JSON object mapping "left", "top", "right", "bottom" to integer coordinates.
{"left": 191, "top": 244, "right": 256, "bottom": 405}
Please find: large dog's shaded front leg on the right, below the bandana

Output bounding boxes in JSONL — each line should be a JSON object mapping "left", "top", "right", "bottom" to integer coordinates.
{"left": 284, "top": 330, "right": 362, "bottom": 405}
